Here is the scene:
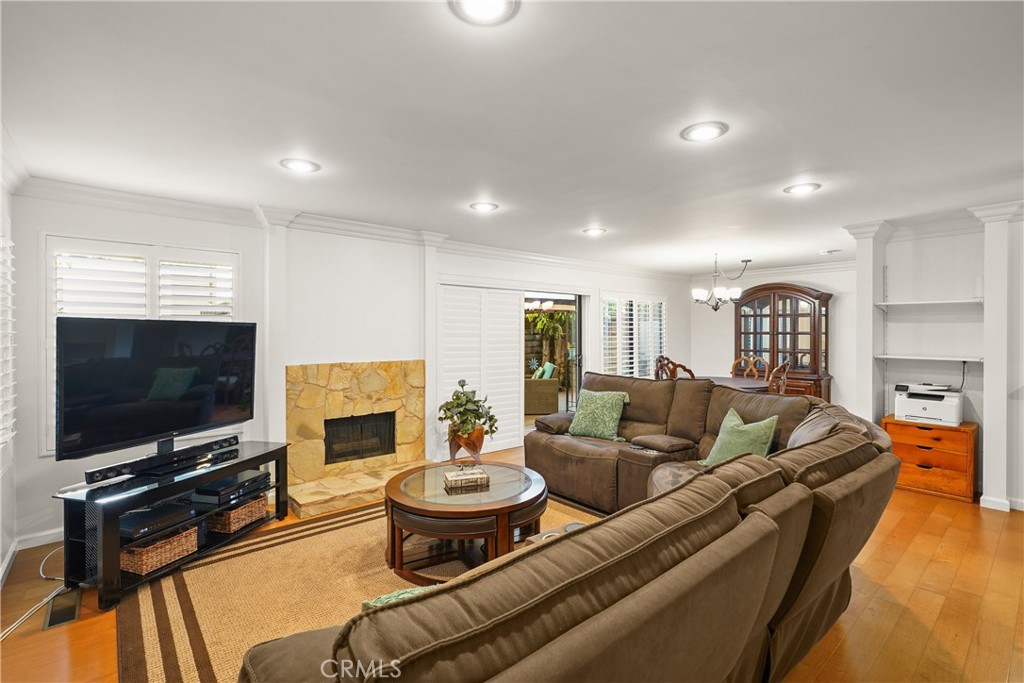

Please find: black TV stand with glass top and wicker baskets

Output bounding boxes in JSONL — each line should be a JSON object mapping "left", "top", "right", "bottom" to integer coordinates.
{"left": 54, "top": 441, "right": 288, "bottom": 609}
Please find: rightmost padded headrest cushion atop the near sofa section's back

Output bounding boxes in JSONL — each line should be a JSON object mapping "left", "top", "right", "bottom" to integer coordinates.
{"left": 769, "top": 431, "right": 879, "bottom": 490}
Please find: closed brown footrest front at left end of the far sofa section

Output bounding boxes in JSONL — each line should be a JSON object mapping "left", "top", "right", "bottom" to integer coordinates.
{"left": 525, "top": 431, "right": 624, "bottom": 512}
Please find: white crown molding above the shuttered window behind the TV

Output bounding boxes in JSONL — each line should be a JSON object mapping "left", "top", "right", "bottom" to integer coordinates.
{"left": 17, "top": 176, "right": 262, "bottom": 228}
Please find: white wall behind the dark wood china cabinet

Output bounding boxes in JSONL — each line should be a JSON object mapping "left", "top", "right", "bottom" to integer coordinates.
{"left": 684, "top": 261, "right": 857, "bottom": 405}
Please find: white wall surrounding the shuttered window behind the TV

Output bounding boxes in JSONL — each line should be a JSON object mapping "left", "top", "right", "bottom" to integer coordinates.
{"left": 12, "top": 193, "right": 267, "bottom": 548}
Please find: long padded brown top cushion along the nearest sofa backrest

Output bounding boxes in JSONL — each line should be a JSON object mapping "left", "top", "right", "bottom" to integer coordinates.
{"left": 336, "top": 477, "right": 745, "bottom": 681}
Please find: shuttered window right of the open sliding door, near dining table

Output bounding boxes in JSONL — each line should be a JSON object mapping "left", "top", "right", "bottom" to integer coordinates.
{"left": 601, "top": 297, "right": 665, "bottom": 377}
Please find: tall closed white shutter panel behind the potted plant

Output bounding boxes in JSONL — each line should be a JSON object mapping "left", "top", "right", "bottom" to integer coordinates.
{"left": 435, "top": 285, "right": 522, "bottom": 457}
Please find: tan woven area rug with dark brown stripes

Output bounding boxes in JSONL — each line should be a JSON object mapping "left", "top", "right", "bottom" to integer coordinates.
{"left": 117, "top": 501, "right": 595, "bottom": 683}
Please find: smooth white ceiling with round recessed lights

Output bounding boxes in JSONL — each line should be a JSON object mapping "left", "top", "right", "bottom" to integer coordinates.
{"left": 2, "top": 0, "right": 1024, "bottom": 272}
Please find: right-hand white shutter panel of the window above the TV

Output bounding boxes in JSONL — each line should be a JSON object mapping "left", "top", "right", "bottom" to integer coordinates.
{"left": 160, "top": 261, "right": 234, "bottom": 321}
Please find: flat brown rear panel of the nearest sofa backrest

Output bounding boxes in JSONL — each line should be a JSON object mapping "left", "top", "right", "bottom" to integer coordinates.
{"left": 485, "top": 513, "right": 777, "bottom": 683}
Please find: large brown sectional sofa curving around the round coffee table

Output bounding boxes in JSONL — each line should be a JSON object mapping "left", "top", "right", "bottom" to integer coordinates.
{"left": 240, "top": 377, "right": 899, "bottom": 683}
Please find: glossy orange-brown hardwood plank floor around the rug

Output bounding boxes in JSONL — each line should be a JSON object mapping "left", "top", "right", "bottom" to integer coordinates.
{"left": 0, "top": 449, "right": 1024, "bottom": 683}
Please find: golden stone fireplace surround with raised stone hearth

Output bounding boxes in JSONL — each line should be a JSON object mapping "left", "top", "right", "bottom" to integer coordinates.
{"left": 285, "top": 360, "right": 426, "bottom": 516}
